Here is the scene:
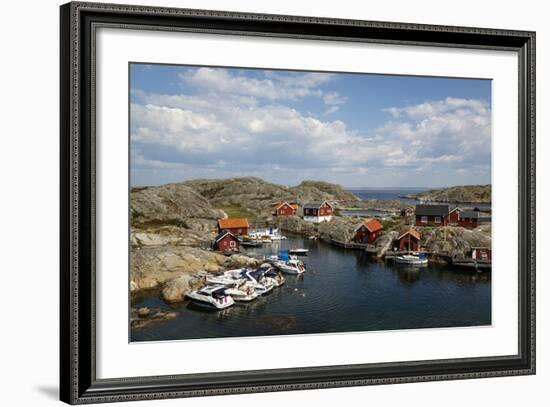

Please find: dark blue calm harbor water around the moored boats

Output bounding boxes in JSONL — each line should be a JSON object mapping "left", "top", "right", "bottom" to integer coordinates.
{"left": 131, "top": 237, "right": 491, "bottom": 341}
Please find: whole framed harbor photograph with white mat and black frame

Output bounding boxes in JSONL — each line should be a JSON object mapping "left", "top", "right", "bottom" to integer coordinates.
{"left": 60, "top": 3, "right": 535, "bottom": 404}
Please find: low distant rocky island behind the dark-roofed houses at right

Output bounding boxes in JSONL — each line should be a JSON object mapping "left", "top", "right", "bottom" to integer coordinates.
{"left": 401, "top": 184, "right": 491, "bottom": 203}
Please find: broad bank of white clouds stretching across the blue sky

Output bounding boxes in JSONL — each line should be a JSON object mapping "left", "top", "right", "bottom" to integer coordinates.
{"left": 131, "top": 68, "right": 491, "bottom": 185}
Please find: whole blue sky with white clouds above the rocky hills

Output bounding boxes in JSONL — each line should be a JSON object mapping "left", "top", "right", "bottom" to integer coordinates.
{"left": 130, "top": 64, "right": 491, "bottom": 187}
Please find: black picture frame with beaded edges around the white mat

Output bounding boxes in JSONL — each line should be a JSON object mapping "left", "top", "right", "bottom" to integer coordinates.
{"left": 60, "top": 2, "right": 535, "bottom": 404}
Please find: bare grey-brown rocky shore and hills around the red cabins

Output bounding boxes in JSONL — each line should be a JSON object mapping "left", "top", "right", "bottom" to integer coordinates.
{"left": 130, "top": 178, "right": 491, "bottom": 314}
